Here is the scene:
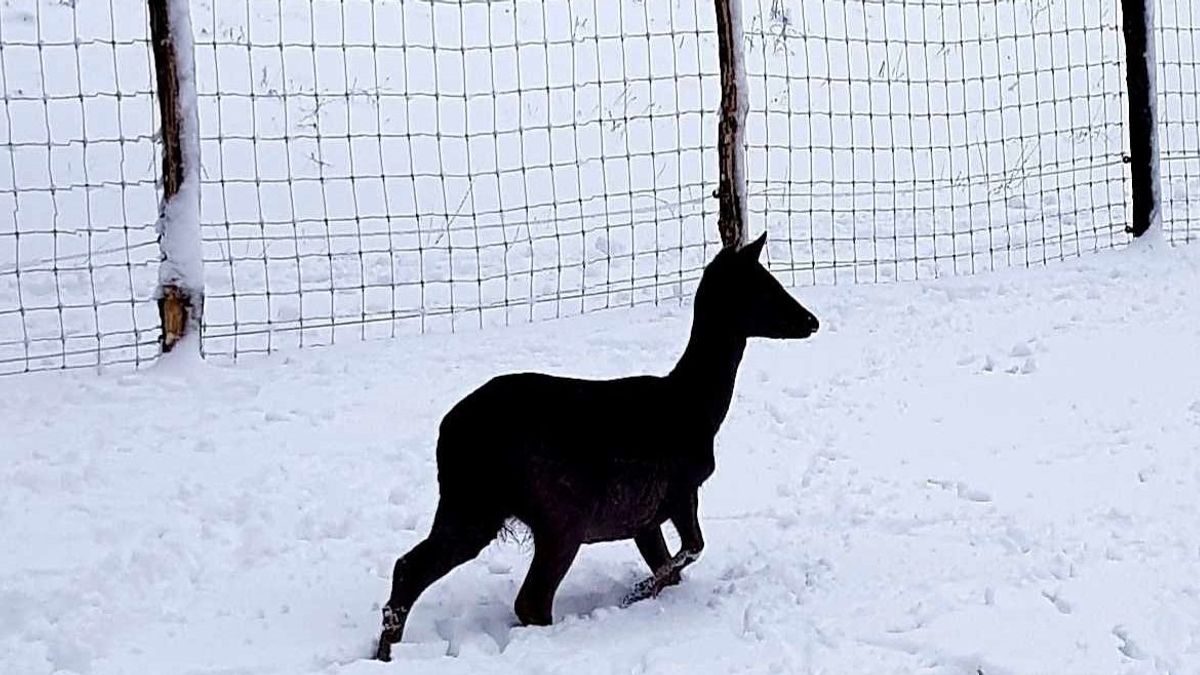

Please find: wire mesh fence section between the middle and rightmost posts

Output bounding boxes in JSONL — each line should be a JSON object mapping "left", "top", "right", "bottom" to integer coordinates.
{"left": 749, "top": 0, "right": 1127, "bottom": 283}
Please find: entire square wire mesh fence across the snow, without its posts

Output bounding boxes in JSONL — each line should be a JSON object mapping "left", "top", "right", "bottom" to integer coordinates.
{"left": 0, "top": 0, "right": 1180, "bottom": 374}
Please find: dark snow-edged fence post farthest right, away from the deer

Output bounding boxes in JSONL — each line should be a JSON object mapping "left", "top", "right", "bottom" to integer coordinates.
{"left": 1121, "top": 0, "right": 1162, "bottom": 237}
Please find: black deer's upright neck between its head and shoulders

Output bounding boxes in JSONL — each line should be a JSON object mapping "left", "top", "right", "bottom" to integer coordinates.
{"left": 667, "top": 325, "right": 746, "bottom": 435}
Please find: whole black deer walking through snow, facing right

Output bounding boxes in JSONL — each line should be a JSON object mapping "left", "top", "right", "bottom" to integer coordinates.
{"left": 376, "top": 230, "right": 818, "bottom": 661}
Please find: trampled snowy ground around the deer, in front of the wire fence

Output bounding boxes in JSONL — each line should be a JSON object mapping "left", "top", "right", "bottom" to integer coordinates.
{"left": 0, "top": 239, "right": 1200, "bottom": 675}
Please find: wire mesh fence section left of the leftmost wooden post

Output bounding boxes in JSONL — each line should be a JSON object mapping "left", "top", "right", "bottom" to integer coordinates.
{"left": 0, "top": 1, "right": 158, "bottom": 374}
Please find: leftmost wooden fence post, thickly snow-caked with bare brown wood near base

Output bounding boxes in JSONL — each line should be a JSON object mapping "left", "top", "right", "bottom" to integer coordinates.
{"left": 149, "top": 0, "right": 204, "bottom": 353}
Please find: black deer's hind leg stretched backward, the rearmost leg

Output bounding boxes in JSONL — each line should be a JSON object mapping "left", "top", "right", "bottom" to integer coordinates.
{"left": 376, "top": 500, "right": 504, "bottom": 661}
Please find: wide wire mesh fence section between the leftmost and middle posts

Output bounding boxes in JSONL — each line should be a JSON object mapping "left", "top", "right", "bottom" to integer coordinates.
{"left": 197, "top": 1, "right": 718, "bottom": 353}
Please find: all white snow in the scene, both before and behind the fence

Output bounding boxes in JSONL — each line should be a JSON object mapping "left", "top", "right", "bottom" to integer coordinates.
{"left": 0, "top": 0, "right": 1200, "bottom": 675}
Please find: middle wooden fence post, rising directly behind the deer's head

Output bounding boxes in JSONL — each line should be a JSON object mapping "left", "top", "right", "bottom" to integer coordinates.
{"left": 716, "top": 0, "right": 749, "bottom": 246}
